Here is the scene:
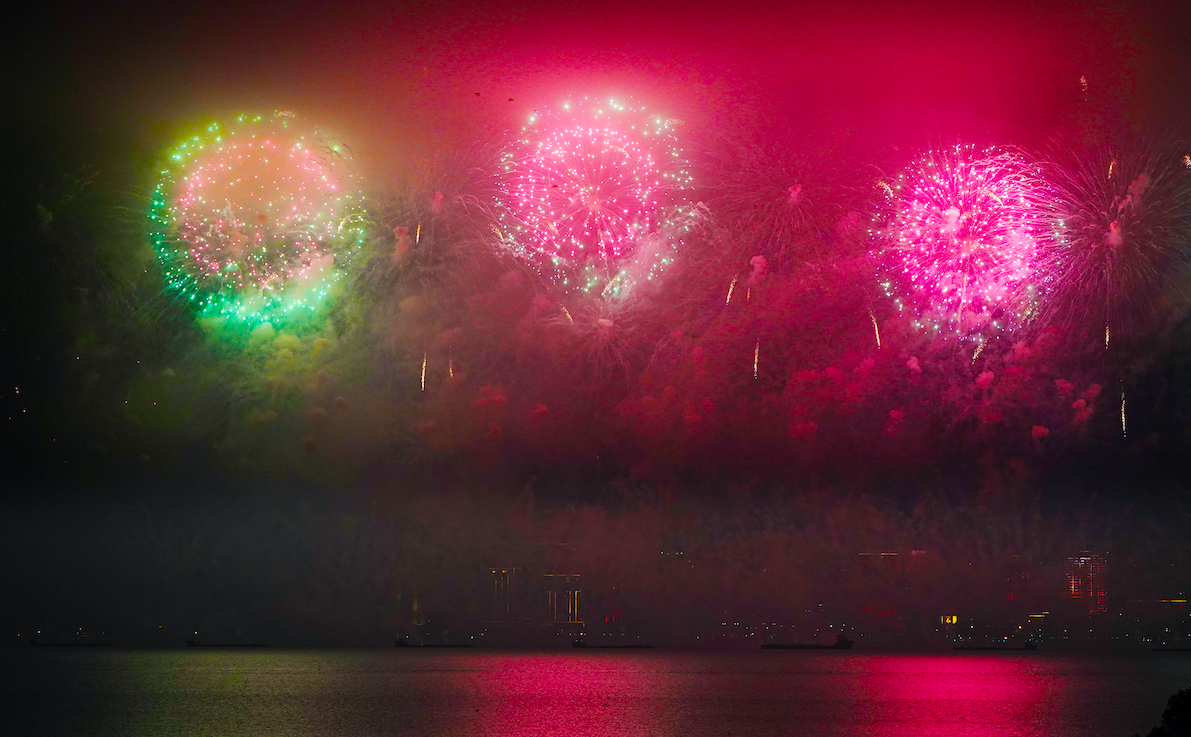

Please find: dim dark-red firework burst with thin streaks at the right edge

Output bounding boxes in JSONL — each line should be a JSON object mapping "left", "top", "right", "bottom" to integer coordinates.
{"left": 1047, "top": 136, "right": 1191, "bottom": 345}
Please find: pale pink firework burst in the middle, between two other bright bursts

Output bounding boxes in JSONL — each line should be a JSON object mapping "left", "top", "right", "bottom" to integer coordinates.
{"left": 500, "top": 98, "right": 690, "bottom": 291}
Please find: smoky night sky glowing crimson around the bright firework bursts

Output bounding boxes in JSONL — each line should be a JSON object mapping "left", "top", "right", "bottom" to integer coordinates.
{"left": 0, "top": 1, "right": 1191, "bottom": 644}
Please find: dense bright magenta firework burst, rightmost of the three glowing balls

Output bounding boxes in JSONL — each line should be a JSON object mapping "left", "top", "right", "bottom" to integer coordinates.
{"left": 873, "top": 145, "right": 1054, "bottom": 339}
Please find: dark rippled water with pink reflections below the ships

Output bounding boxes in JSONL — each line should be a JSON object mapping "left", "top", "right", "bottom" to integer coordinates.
{"left": 5, "top": 649, "right": 1191, "bottom": 737}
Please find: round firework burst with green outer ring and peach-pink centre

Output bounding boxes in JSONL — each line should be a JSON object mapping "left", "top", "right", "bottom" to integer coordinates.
{"left": 149, "top": 113, "right": 364, "bottom": 324}
